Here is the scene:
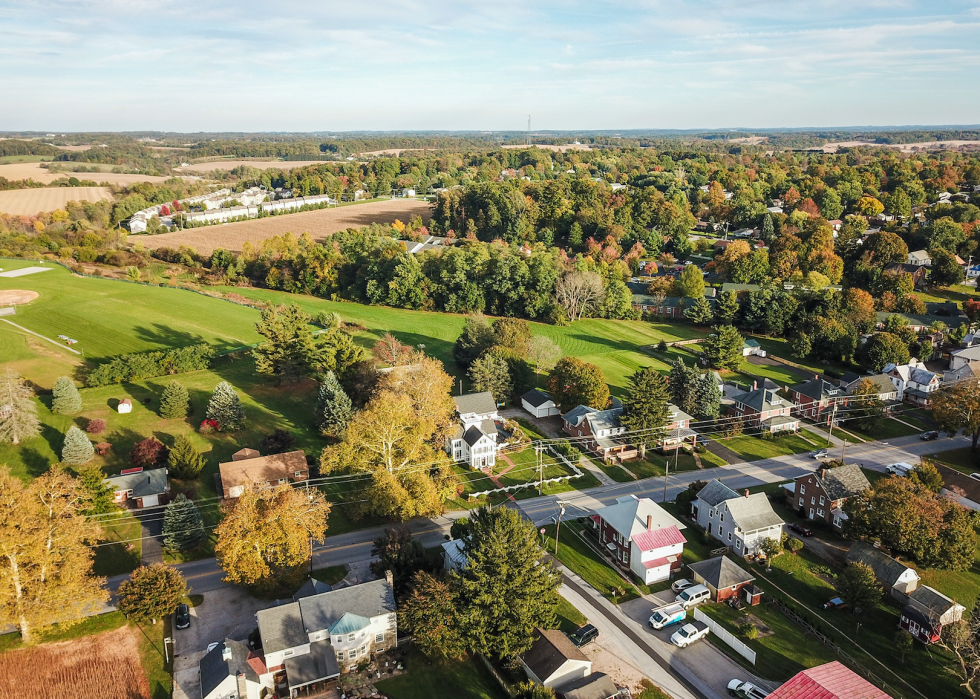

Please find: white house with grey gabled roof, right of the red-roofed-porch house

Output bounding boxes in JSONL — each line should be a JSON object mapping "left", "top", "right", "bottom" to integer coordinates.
{"left": 692, "top": 479, "right": 783, "bottom": 556}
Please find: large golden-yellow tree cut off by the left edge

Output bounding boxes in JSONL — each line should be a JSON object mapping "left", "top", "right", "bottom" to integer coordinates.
{"left": 0, "top": 467, "right": 109, "bottom": 643}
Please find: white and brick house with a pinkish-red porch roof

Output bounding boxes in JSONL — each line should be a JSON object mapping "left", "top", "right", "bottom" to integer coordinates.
{"left": 591, "top": 495, "right": 687, "bottom": 585}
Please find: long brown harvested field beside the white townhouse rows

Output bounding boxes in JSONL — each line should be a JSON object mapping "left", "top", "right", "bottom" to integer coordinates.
{"left": 142, "top": 199, "right": 432, "bottom": 255}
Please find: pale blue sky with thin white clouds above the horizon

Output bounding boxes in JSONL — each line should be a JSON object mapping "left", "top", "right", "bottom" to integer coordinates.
{"left": 0, "top": 0, "right": 980, "bottom": 131}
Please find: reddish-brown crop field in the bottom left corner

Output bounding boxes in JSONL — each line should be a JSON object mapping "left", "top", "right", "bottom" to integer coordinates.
{"left": 0, "top": 626, "right": 150, "bottom": 699}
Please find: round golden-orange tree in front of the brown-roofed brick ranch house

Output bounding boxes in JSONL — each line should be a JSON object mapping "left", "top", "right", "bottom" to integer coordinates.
{"left": 214, "top": 484, "right": 330, "bottom": 592}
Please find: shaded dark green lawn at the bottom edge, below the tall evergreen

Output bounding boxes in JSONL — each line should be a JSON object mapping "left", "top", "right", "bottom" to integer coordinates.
{"left": 376, "top": 647, "right": 507, "bottom": 699}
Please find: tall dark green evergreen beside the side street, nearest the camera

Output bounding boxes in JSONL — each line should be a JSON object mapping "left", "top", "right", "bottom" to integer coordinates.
{"left": 455, "top": 507, "right": 561, "bottom": 658}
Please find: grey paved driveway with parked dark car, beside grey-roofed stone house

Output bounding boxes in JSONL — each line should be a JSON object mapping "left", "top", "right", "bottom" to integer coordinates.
{"left": 173, "top": 586, "right": 280, "bottom": 699}
